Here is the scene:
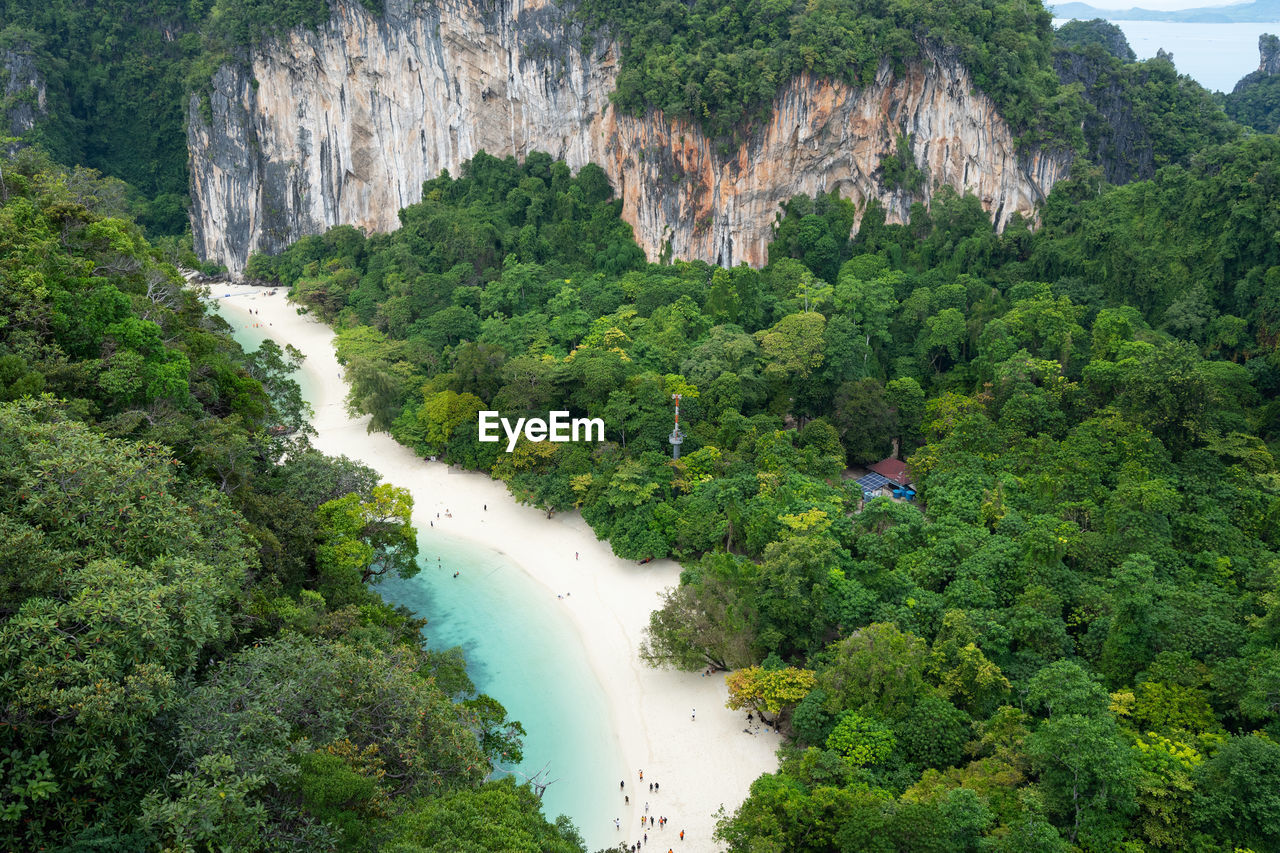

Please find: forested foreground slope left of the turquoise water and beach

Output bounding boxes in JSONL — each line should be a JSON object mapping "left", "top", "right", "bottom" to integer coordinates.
{"left": 0, "top": 150, "right": 582, "bottom": 853}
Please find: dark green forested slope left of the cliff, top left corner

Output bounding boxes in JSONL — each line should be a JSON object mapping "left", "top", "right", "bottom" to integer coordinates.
{"left": 0, "top": 0, "right": 383, "bottom": 234}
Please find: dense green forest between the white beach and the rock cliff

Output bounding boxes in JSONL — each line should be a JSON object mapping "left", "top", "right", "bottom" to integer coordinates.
{"left": 251, "top": 137, "right": 1280, "bottom": 853}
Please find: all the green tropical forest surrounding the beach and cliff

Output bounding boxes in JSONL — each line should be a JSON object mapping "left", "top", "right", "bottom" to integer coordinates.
{"left": 0, "top": 0, "right": 1280, "bottom": 853}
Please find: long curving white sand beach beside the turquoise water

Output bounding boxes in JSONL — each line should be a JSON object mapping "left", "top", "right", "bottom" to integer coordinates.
{"left": 212, "top": 284, "right": 780, "bottom": 853}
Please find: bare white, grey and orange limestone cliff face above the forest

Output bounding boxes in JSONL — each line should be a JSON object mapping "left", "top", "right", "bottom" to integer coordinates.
{"left": 188, "top": 0, "right": 1070, "bottom": 273}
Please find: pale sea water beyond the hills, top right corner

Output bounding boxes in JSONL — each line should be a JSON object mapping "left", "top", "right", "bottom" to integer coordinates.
{"left": 1053, "top": 18, "right": 1280, "bottom": 92}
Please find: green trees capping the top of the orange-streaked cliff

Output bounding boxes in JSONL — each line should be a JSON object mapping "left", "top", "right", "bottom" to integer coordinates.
{"left": 580, "top": 0, "right": 1079, "bottom": 147}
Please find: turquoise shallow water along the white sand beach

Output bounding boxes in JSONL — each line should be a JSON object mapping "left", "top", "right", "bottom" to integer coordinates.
{"left": 215, "top": 291, "right": 622, "bottom": 850}
